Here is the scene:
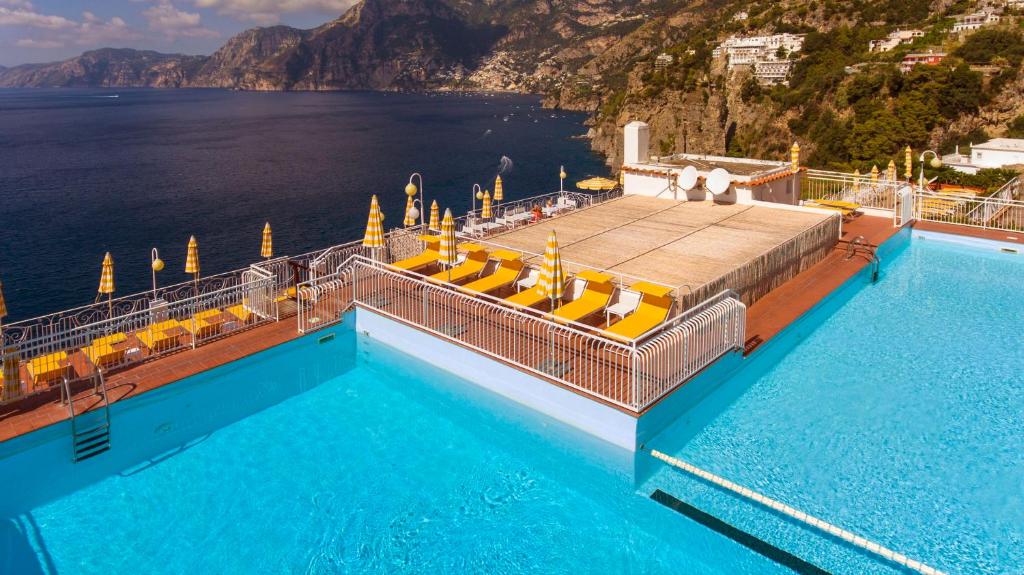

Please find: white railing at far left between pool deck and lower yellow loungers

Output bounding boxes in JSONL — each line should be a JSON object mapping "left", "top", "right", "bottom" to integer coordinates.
{"left": 0, "top": 269, "right": 276, "bottom": 403}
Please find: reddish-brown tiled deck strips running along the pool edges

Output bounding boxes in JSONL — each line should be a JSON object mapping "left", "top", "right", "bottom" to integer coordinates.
{"left": 0, "top": 211, "right": 991, "bottom": 441}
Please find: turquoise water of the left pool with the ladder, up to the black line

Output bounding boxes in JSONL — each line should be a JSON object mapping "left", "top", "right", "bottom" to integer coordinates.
{"left": 0, "top": 328, "right": 779, "bottom": 574}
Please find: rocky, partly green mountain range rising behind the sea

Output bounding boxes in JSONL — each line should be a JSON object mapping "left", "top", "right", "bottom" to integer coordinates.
{"left": 0, "top": 0, "right": 1024, "bottom": 171}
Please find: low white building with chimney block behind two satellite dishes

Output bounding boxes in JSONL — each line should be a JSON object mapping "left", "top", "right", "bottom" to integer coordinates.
{"left": 623, "top": 122, "right": 800, "bottom": 206}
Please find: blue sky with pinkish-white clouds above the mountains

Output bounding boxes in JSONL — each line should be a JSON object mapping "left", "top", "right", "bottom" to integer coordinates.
{"left": 0, "top": 0, "right": 355, "bottom": 67}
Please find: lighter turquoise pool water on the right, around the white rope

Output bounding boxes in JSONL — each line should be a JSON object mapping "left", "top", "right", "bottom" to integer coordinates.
{"left": 643, "top": 231, "right": 1024, "bottom": 574}
